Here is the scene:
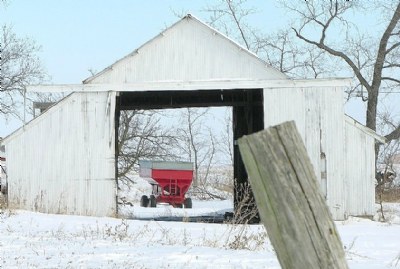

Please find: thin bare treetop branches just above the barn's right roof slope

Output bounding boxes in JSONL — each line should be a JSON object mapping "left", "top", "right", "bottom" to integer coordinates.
{"left": 204, "top": 0, "right": 335, "bottom": 78}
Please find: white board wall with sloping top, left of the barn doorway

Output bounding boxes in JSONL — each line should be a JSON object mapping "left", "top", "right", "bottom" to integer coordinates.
{"left": 4, "top": 92, "right": 116, "bottom": 216}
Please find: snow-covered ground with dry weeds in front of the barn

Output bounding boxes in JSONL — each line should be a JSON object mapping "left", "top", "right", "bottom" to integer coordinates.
{"left": 0, "top": 201, "right": 400, "bottom": 269}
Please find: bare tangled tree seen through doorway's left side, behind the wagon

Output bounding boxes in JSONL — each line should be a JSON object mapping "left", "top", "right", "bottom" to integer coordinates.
{"left": 118, "top": 110, "right": 175, "bottom": 182}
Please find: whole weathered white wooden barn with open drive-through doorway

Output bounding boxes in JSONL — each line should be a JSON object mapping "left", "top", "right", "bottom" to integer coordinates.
{"left": 1, "top": 15, "right": 383, "bottom": 220}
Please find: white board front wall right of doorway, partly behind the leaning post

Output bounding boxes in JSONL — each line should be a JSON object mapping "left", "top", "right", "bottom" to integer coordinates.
{"left": 264, "top": 87, "right": 347, "bottom": 220}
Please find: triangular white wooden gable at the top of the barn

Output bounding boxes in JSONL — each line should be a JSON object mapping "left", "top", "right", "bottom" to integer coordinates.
{"left": 83, "top": 15, "right": 287, "bottom": 84}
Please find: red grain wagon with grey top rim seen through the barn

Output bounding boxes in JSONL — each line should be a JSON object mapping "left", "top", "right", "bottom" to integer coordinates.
{"left": 139, "top": 161, "right": 193, "bottom": 208}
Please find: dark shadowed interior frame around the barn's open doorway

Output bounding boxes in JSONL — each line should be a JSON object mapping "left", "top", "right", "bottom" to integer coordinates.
{"left": 115, "top": 89, "right": 264, "bottom": 220}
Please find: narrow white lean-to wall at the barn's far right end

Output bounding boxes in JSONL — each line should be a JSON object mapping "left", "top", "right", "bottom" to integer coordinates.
{"left": 345, "top": 121, "right": 375, "bottom": 216}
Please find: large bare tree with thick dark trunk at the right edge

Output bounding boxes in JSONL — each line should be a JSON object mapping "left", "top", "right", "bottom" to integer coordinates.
{"left": 282, "top": 0, "right": 400, "bottom": 147}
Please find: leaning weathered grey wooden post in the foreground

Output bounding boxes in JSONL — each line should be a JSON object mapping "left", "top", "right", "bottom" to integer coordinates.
{"left": 239, "top": 122, "right": 348, "bottom": 269}
